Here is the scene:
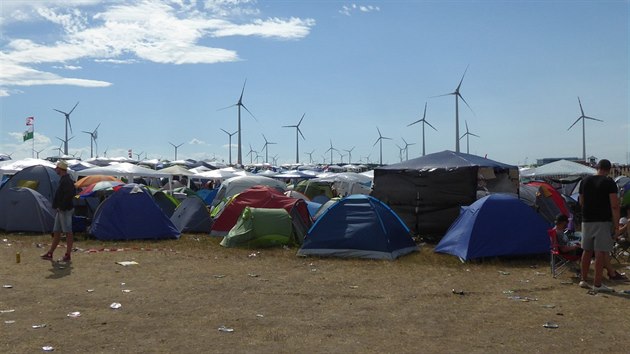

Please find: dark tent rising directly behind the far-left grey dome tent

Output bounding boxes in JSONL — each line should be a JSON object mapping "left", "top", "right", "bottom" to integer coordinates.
{"left": 2, "top": 165, "right": 59, "bottom": 203}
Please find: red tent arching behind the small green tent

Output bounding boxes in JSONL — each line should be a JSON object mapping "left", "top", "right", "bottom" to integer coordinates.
{"left": 210, "top": 186, "right": 312, "bottom": 236}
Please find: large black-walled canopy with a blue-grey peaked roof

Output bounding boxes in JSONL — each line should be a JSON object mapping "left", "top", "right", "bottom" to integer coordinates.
{"left": 371, "top": 150, "right": 518, "bottom": 238}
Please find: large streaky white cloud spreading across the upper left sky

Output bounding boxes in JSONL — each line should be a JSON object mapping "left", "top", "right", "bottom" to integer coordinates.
{"left": 0, "top": 0, "right": 315, "bottom": 96}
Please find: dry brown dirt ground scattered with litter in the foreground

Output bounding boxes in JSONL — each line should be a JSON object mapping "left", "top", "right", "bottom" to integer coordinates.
{"left": 0, "top": 234, "right": 630, "bottom": 353}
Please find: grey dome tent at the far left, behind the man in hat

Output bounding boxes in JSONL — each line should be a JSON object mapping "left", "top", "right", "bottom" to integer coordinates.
{"left": 0, "top": 186, "right": 55, "bottom": 233}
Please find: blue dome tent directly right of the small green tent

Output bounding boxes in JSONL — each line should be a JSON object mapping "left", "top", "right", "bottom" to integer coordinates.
{"left": 298, "top": 194, "right": 418, "bottom": 260}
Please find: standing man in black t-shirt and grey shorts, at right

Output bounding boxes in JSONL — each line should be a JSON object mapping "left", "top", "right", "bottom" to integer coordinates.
{"left": 580, "top": 159, "right": 619, "bottom": 292}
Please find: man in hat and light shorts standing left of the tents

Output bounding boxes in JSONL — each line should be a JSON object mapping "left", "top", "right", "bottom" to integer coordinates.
{"left": 41, "top": 160, "right": 75, "bottom": 262}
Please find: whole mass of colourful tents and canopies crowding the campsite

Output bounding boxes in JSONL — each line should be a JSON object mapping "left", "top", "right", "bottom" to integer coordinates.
{"left": 0, "top": 151, "right": 630, "bottom": 260}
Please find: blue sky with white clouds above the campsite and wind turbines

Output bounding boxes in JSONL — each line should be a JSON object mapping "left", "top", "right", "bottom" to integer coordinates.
{"left": 0, "top": 0, "right": 630, "bottom": 165}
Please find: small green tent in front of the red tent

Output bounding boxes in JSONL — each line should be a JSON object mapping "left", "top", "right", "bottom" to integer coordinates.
{"left": 221, "top": 207, "right": 293, "bottom": 248}
